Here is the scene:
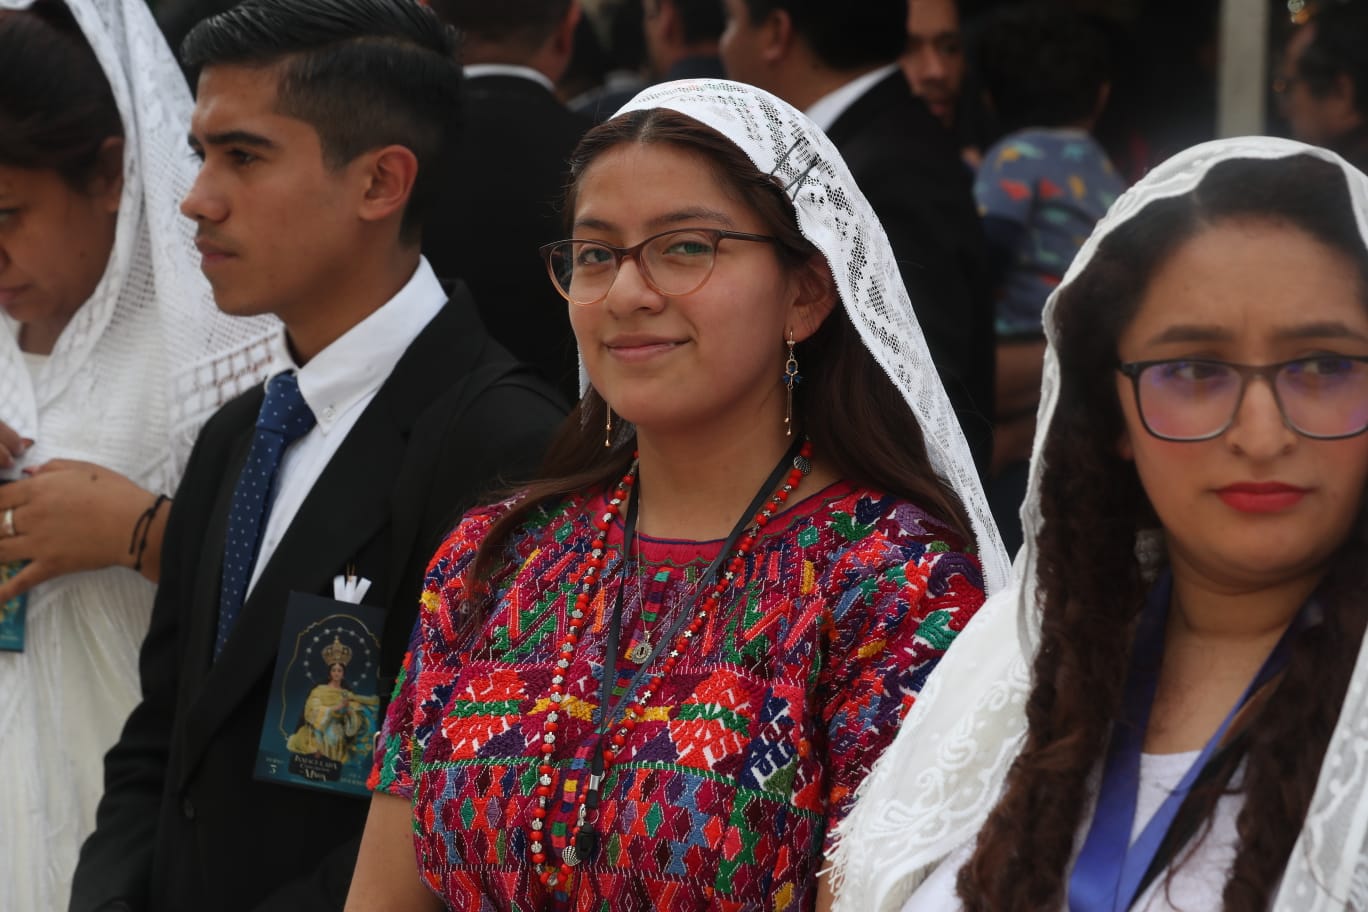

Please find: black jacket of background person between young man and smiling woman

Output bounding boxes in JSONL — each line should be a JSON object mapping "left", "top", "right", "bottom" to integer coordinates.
{"left": 423, "top": 75, "right": 591, "bottom": 401}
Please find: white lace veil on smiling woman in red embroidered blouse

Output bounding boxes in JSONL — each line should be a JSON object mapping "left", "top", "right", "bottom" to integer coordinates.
{"left": 618, "top": 79, "right": 1010, "bottom": 592}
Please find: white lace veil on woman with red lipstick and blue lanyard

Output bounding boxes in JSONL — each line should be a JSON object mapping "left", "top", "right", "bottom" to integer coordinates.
{"left": 832, "top": 137, "right": 1368, "bottom": 912}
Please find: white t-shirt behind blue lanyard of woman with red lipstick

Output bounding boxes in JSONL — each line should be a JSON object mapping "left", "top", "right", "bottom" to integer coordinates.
{"left": 903, "top": 751, "right": 1244, "bottom": 912}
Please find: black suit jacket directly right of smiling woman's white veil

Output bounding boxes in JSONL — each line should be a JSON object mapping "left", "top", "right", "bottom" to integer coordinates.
{"left": 826, "top": 71, "right": 996, "bottom": 473}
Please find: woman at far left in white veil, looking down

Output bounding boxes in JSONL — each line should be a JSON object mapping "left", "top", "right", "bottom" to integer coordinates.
{"left": 0, "top": 0, "right": 272, "bottom": 912}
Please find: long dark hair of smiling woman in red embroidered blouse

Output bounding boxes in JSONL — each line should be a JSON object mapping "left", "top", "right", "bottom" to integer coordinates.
{"left": 471, "top": 108, "right": 974, "bottom": 581}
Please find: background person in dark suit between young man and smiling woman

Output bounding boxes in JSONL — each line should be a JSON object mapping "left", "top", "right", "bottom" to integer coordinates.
{"left": 423, "top": 0, "right": 592, "bottom": 399}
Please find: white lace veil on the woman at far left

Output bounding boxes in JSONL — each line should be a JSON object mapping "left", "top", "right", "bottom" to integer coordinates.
{"left": 0, "top": 0, "right": 278, "bottom": 491}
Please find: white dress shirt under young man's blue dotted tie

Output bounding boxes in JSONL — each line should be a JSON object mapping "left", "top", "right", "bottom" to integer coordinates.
{"left": 240, "top": 258, "right": 446, "bottom": 595}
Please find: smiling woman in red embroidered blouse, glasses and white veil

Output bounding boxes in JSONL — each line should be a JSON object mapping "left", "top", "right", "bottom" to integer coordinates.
{"left": 347, "top": 82, "right": 1007, "bottom": 912}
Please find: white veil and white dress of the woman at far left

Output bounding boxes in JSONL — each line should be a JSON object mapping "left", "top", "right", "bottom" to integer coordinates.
{"left": 0, "top": 0, "right": 278, "bottom": 912}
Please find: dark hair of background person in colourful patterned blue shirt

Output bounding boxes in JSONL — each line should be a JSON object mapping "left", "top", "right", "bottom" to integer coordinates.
{"left": 977, "top": 4, "right": 1109, "bottom": 131}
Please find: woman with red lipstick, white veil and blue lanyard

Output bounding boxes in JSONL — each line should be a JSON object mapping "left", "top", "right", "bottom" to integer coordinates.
{"left": 833, "top": 138, "right": 1368, "bottom": 912}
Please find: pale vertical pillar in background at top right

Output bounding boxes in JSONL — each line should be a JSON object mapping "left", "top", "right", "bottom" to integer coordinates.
{"left": 1216, "top": 0, "right": 1270, "bottom": 137}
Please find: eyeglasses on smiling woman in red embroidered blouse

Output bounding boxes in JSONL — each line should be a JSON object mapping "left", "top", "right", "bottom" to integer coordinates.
{"left": 542, "top": 228, "right": 777, "bottom": 306}
